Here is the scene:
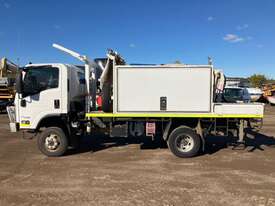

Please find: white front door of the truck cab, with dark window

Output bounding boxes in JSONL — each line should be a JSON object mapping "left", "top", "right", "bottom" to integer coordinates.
{"left": 18, "top": 65, "right": 62, "bottom": 129}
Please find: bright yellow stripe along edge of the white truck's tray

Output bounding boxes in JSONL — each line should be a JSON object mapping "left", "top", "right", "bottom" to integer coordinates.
{"left": 86, "top": 113, "right": 264, "bottom": 118}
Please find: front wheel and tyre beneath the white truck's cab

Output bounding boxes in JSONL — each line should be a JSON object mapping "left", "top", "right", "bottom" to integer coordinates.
{"left": 37, "top": 127, "right": 68, "bottom": 157}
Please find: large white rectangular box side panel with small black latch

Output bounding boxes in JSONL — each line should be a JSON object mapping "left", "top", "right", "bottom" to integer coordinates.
{"left": 113, "top": 65, "right": 213, "bottom": 113}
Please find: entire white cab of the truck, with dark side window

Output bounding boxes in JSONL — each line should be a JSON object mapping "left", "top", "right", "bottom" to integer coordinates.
{"left": 15, "top": 64, "right": 86, "bottom": 130}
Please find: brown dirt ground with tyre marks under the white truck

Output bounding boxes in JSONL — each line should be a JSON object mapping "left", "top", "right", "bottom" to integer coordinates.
{"left": 0, "top": 106, "right": 275, "bottom": 206}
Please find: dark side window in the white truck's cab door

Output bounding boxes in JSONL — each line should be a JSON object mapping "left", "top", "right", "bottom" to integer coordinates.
{"left": 23, "top": 66, "right": 59, "bottom": 96}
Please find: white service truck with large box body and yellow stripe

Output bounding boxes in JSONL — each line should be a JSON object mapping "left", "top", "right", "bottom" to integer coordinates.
{"left": 9, "top": 45, "right": 264, "bottom": 157}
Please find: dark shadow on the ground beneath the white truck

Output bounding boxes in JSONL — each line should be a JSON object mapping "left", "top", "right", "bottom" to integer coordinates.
{"left": 67, "top": 131, "right": 275, "bottom": 155}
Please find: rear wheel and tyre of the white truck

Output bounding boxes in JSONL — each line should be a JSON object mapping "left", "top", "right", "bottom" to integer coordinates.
{"left": 168, "top": 126, "right": 201, "bottom": 158}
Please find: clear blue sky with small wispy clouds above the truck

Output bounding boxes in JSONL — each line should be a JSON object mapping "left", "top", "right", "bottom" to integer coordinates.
{"left": 0, "top": 0, "right": 275, "bottom": 78}
